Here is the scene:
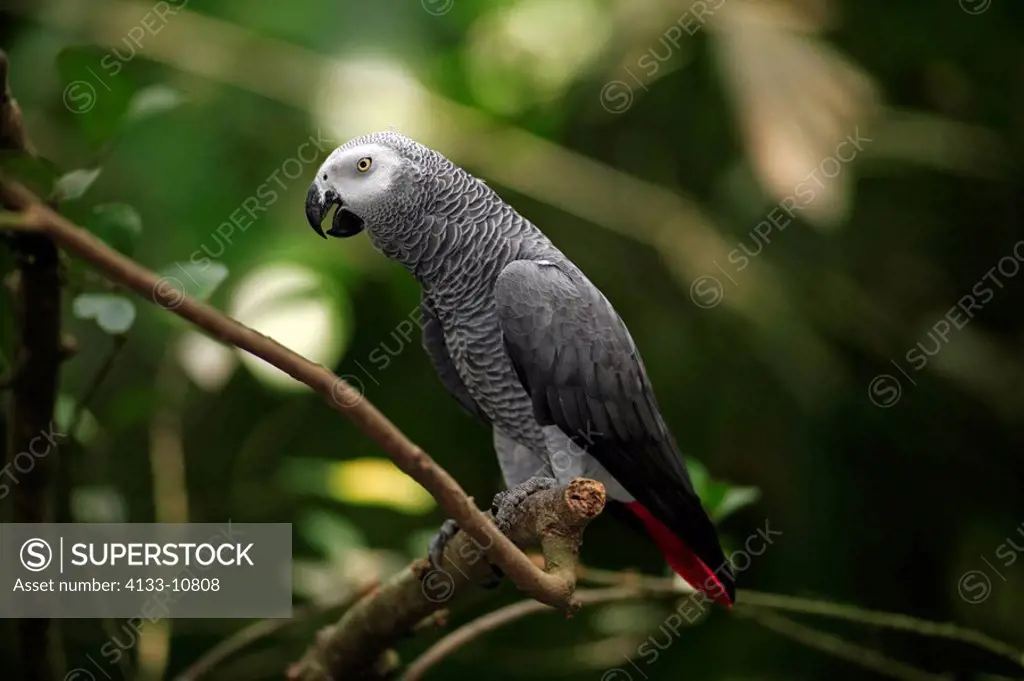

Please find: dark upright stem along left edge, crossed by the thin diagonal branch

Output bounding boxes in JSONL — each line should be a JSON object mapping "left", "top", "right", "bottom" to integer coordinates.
{"left": 0, "top": 51, "right": 62, "bottom": 681}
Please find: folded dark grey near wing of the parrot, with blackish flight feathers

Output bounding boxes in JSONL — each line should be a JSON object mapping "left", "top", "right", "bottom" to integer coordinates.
{"left": 495, "top": 260, "right": 731, "bottom": 588}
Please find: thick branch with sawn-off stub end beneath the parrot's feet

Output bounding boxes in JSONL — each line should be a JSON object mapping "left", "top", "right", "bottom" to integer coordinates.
{"left": 288, "top": 478, "right": 605, "bottom": 681}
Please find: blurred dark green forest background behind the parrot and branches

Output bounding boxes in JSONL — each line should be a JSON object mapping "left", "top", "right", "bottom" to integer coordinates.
{"left": 0, "top": 0, "right": 1024, "bottom": 681}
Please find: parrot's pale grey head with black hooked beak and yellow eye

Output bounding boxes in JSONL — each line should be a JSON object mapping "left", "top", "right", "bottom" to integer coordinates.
{"left": 306, "top": 132, "right": 434, "bottom": 244}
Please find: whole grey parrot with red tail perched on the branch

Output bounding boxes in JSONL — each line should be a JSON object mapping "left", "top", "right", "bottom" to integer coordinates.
{"left": 305, "top": 132, "right": 735, "bottom": 606}
